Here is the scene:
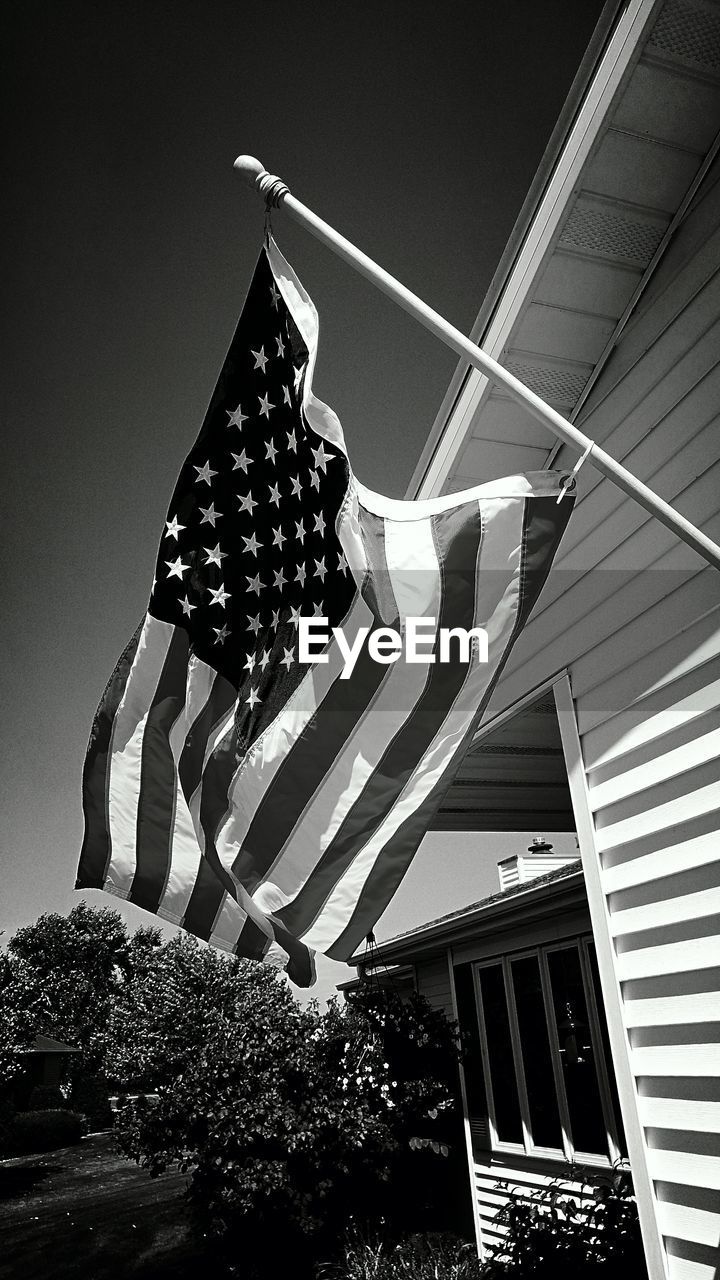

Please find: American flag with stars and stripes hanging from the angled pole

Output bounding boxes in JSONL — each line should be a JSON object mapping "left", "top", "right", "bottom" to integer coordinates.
{"left": 76, "top": 241, "right": 571, "bottom": 986}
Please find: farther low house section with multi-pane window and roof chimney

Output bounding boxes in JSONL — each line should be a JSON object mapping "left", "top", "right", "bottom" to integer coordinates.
{"left": 343, "top": 841, "right": 626, "bottom": 1253}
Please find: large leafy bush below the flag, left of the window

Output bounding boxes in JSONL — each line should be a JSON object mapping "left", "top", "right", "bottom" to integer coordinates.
{"left": 112, "top": 961, "right": 457, "bottom": 1276}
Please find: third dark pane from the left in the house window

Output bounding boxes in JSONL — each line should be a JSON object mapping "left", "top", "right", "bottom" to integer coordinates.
{"left": 547, "top": 947, "right": 607, "bottom": 1156}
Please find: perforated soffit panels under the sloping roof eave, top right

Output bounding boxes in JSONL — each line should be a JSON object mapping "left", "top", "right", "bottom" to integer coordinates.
{"left": 430, "top": 0, "right": 720, "bottom": 492}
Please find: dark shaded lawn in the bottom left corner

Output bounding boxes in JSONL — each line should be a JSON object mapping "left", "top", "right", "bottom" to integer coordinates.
{"left": 0, "top": 1134, "right": 206, "bottom": 1280}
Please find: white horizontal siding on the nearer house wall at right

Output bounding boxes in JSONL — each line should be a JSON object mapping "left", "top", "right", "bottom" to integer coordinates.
{"left": 481, "top": 154, "right": 720, "bottom": 1280}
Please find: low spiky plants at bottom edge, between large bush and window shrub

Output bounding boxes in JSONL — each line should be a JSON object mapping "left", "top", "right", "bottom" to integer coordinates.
{"left": 318, "top": 1231, "right": 483, "bottom": 1280}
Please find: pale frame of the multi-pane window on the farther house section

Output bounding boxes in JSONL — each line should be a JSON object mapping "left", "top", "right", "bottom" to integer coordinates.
{"left": 471, "top": 933, "right": 623, "bottom": 1167}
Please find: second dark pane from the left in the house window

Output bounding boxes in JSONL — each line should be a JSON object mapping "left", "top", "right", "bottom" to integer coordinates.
{"left": 511, "top": 956, "right": 562, "bottom": 1147}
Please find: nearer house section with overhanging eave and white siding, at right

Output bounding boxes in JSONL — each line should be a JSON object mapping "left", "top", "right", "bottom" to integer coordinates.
{"left": 361, "top": 0, "right": 720, "bottom": 1280}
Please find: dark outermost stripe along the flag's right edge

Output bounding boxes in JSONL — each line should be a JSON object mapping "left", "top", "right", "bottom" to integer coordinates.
{"left": 319, "top": 498, "right": 568, "bottom": 960}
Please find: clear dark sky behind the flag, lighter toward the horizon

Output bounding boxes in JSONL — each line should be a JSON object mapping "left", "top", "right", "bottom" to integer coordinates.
{"left": 0, "top": 0, "right": 602, "bottom": 987}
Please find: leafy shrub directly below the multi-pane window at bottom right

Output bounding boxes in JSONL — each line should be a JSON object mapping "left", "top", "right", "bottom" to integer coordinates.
{"left": 483, "top": 1167, "right": 647, "bottom": 1280}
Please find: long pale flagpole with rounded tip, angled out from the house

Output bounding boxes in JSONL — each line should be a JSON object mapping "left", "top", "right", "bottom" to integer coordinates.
{"left": 234, "top": 156, "right": 720, "bottom": 568}
